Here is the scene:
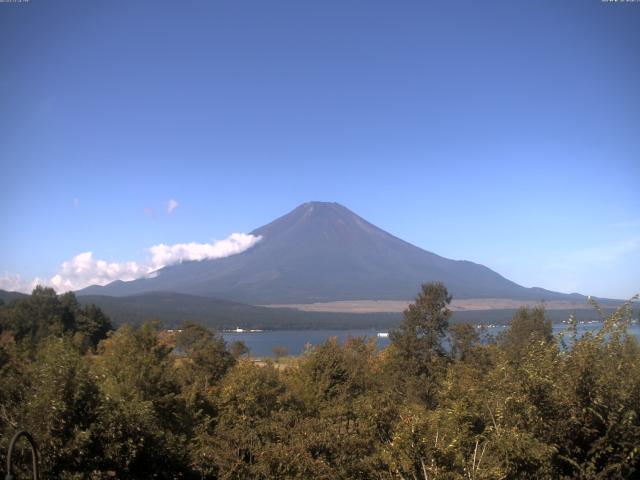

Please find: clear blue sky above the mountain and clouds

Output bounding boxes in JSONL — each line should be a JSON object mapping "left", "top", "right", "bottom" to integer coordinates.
{"left": 0, "top": 0, "right": 640, "bottom": 298}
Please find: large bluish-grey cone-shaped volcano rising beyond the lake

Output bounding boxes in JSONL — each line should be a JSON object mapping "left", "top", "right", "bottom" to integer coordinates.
{"left": 78, "top": 202, "right": 580, "bottom": 304}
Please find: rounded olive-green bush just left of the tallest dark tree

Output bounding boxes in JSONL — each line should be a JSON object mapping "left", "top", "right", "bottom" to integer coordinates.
{"left": 285, "top": 337, "right": 395, "bottom": 478}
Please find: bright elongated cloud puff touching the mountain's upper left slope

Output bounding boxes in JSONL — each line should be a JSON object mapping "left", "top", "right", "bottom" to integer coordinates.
{"left": 149, "top": 233, "right": 261, "bottom": 268}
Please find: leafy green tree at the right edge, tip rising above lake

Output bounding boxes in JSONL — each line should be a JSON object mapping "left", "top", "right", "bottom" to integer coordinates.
{"left": 547, "top": 297, "right": 640, "bottom": 479}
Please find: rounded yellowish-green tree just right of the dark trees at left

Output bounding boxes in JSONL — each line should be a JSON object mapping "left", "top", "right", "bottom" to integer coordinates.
{"left": 92, "top": 322, "right": 191, "bottom": 478}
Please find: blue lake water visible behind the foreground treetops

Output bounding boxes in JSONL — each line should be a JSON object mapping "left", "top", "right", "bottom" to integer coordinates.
{"left": 223, "top": 322, "right": 640, "bottom": 357}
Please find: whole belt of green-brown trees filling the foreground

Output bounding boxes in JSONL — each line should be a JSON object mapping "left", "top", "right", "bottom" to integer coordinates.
{"left": 0, "top": 283, "right": 640, "bottom": 480}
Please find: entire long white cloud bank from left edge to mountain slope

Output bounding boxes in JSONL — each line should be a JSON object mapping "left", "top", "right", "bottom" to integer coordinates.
{"left": 0, "top": 233, "right": 262, "bottom": 293}
